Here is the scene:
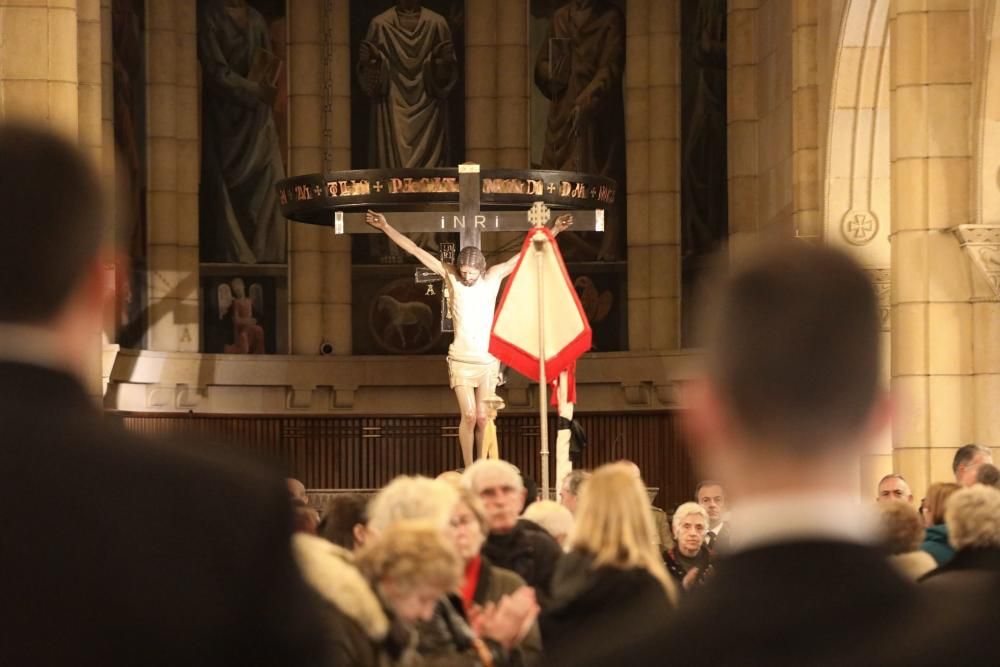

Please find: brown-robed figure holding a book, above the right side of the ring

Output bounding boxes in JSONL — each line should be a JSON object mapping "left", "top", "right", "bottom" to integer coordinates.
{"left": 535, "top": 0, "right": 625, "bottom": 259}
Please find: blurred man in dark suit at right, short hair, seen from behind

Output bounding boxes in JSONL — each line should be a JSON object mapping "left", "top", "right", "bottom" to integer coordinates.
{"left": 556, "top": 243, "right": 997, "bottom": 667}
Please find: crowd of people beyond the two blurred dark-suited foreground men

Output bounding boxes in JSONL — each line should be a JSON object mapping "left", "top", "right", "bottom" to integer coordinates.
{"left": 278, "top": 438, "right": 1000, "bottom": 666}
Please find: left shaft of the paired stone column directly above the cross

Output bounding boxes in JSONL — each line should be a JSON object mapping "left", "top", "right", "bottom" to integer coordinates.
{"left": 465, "top": 0, "right": 500, "bottom": 169}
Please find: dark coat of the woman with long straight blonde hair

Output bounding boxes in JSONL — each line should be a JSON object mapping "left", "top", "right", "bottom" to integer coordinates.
{"left": 539, "top": 551, "right": 671, "bottom": 666}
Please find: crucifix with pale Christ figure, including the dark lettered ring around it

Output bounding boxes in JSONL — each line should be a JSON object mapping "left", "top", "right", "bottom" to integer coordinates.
{"left": 278, "top": 163, "right": 617, "bottom": 465}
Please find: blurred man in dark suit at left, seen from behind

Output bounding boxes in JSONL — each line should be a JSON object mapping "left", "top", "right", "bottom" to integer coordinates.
{"left": 0, "top": 125, "right": 326, "bottom": 666}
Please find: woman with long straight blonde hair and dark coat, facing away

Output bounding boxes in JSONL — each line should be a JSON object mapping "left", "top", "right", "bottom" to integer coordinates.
{"left": 541, "top": 463, "right": 677, "bottom": 664}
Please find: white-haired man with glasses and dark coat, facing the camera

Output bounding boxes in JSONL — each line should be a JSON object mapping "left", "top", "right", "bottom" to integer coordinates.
{"left": 462, "top": 459, "right": 562, "bottom": 607}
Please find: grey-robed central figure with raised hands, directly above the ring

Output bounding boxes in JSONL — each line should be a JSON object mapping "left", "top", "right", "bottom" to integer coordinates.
{"left": 357, "top": 0, "right": 458, "bottom": 262}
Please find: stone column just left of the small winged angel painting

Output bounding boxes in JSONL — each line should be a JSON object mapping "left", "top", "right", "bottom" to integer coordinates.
{"left": 146, "top": 0, "right": 199, "bottom": 352}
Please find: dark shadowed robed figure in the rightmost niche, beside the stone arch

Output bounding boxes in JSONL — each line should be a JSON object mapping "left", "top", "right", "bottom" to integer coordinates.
{"left": 681, "top": 0, "right": 729, "bottom": 257}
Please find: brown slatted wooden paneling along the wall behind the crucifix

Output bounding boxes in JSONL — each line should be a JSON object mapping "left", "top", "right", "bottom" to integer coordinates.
{"left": 115, "top": 412, "right": 695, "bottom": 510}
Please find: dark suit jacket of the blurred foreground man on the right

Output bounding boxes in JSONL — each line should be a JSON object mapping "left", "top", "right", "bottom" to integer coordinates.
{"left": 620, "top": 541, "right": 998, "bottom": 667}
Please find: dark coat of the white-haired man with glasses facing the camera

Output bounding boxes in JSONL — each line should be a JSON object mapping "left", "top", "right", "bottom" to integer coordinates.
{"left": 482, "top": 519, "right": 562, "bottom": 608}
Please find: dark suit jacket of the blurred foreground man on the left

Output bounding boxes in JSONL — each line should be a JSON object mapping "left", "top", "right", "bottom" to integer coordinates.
{"left": 0, "top": 363, "right": 327, "bottom": 667}
